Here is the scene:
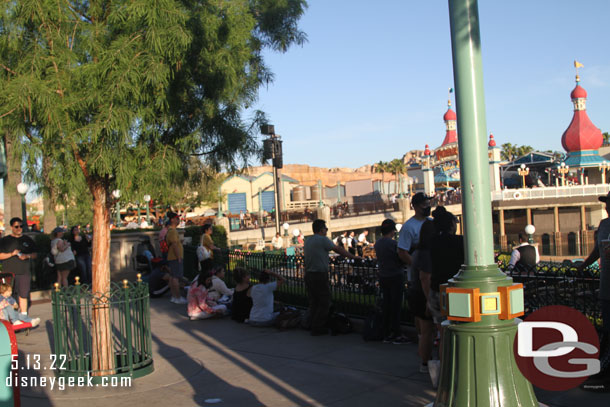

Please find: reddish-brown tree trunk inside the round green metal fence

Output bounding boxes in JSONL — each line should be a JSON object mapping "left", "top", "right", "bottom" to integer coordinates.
{"left": 88, "top": 180, "right": 115, "bottom": 376}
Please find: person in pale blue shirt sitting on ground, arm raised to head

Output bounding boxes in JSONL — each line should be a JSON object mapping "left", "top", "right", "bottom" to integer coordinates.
{"left": 247, "top": 269, "right": 284, "bottom": 326}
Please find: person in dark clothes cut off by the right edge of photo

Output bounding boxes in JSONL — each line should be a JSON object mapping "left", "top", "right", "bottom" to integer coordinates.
{"left": 578, "top": 192, "right": 610, "bottom": 391}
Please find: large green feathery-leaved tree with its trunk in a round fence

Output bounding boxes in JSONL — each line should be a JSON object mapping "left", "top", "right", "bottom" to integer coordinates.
{"left": 0, "top": 0, "right": 306, "bottom": 374}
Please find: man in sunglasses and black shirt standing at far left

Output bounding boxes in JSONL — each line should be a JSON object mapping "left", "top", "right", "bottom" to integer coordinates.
{"left": 0, "top": 218, "right": 38, "bottom": 315}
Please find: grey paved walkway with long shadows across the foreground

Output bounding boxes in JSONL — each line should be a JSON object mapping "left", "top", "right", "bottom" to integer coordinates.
{"left": 11, "top": 299, "right": 610, "bottom": 407}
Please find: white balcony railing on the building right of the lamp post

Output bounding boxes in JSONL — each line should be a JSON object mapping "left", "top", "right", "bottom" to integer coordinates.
{"left": 491, "top": 184, "right": 610, "bottom": 201}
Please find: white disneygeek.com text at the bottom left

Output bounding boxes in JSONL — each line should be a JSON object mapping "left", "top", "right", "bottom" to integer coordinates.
{"left": 5, "top": 373, "right": 131, "bottom": 390}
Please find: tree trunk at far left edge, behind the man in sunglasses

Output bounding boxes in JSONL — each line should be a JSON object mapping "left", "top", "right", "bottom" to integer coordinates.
{"left": 4, "top": 131, "right": 25, "bottom": 225}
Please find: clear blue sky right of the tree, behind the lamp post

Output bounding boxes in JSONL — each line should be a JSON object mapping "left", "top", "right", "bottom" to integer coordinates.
{"left": 251, "top": 0, "right": 610, "bottom": 167}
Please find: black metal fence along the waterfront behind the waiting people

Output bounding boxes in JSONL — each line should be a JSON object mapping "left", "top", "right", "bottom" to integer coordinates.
{"left": 210, "top": 250, "right": 601, "bottom": 328}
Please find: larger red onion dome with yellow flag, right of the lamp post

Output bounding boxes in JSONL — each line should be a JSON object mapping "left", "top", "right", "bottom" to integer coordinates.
{"left": 561, "top": 74, "right": 607, "bottom": 168}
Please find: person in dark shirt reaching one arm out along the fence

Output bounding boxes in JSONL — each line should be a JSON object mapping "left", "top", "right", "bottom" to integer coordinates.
{"left": 303, "top": 219, "right": 361, "bottom": 336}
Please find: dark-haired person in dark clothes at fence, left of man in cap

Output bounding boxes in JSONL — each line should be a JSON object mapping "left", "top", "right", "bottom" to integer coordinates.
{"left": 375, "top": 219, "right": 408, "bottom": 345}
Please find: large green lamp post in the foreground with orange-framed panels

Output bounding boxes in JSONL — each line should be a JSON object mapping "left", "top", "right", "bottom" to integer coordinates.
{"left": 432, "top": 0, "right": 538, "bottom": 407}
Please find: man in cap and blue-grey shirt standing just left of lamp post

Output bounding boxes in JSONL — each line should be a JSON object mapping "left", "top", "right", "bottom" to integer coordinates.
{"left": 398, "top": 192, "right": 434, "bottom": 373}
